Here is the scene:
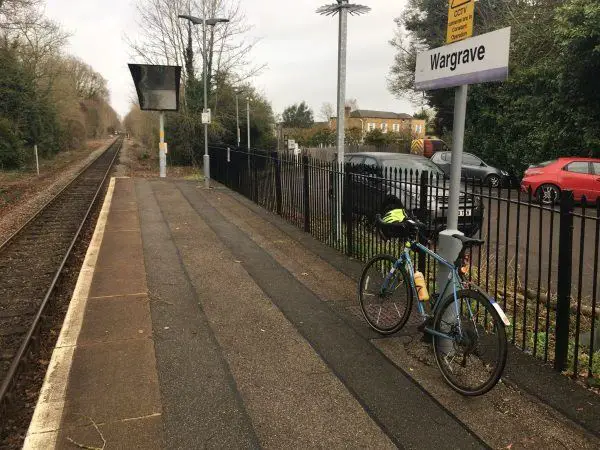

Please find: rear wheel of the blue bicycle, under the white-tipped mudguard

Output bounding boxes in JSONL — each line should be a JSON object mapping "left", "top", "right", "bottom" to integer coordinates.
{"left": 433, "top": 289, "right": 508, "bottom": 396}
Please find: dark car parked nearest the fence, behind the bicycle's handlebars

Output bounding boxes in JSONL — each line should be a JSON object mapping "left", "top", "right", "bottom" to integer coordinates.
{"left": 344, "top": 152, "right": 483, "bottom": 236}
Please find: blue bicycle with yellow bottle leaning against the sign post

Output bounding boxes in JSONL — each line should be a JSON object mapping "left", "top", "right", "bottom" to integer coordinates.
{"left": 358, "top": 216, "right": 510, "bottom": 396}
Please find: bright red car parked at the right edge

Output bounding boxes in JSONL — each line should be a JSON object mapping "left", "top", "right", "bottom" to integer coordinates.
{"left": 521, "top": 157, "right": 600, "bottom": 205}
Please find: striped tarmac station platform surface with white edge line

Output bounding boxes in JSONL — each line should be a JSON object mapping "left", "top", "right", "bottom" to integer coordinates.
{"left": 24, "top": 178, "right": 600, "bottom": 449}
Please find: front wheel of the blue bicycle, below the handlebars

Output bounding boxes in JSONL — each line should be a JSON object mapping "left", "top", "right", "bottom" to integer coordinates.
{"left": 358, "top": 255, "right": 412, "bottom": 334}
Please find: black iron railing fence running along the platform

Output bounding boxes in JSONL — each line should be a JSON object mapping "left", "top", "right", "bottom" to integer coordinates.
{"left": 210, "top": 147, "right": 600, "bottom": 381}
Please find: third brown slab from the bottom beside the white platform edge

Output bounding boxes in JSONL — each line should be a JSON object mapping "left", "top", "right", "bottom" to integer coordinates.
{"left": 78, "top": 295, "right": 152, "bottom": 345}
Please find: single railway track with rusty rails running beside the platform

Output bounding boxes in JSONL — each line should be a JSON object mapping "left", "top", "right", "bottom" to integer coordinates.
{"left": 0, "top": 138, "right": 123, "bottom": 422}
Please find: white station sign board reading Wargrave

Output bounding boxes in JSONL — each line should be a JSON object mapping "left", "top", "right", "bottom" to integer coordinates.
{"left": 415, "top": 27, "right": 510, "bottom": 90}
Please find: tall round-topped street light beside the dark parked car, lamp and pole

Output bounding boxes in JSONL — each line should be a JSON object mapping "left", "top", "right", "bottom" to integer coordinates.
{"left": 317, "top": 0, "right": 371, "bottom": 239}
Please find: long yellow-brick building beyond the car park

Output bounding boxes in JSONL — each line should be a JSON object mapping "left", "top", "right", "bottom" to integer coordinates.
{"left": 329, "top": 107, "right": 425, "bottom": 139}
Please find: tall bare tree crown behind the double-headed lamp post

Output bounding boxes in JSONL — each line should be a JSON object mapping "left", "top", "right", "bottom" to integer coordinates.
{"left": 128, "top": 0, "right": 264, "bottom": 89}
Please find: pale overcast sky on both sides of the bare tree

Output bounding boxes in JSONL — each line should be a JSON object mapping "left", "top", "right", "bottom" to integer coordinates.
{"left": 46, "top": 0, "right": 415, "bottom": 119}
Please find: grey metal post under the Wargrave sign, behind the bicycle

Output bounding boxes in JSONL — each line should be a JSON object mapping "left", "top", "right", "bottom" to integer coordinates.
{"left": 437, "top": 84, "right": 468, "bottom": 288}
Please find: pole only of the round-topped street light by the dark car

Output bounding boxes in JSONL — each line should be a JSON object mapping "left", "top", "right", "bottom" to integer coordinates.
{"left": 334, "top": 3, "right": 348, "bottom": 240}
